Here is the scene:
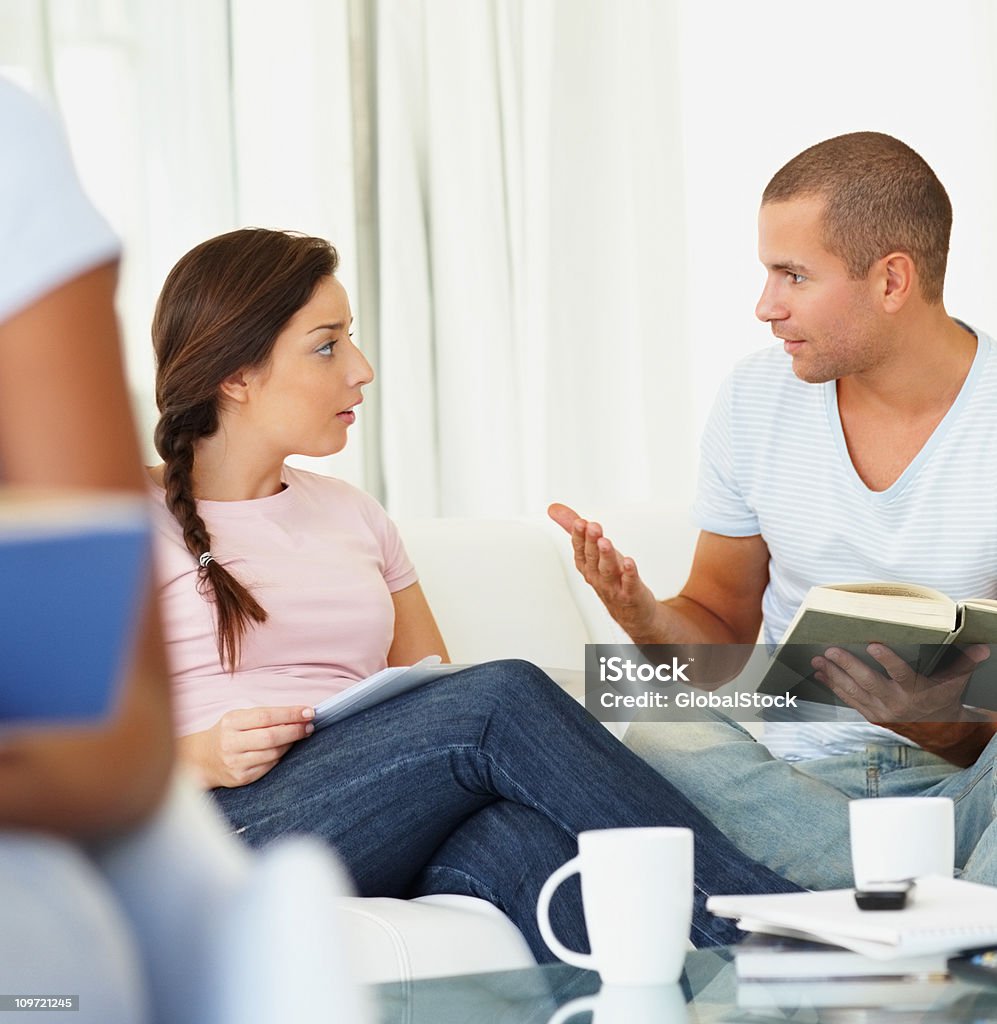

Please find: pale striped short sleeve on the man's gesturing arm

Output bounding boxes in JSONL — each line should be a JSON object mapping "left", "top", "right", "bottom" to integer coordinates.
{"left": 693, "top": 375, "right": 762, "bottom": 537}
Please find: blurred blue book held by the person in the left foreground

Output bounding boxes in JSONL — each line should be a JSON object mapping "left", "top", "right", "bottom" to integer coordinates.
{"left": 0, "top": 488, "right": 150, "bottom": 730}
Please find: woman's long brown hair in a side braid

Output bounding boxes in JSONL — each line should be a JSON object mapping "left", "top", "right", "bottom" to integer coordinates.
{"left": 153, "top": 227, "right": 339, "bottom": 673}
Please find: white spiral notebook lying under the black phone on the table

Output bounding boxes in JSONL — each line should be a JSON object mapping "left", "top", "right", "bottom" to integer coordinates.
{"left": 706, "top": 878, "right": 997, "bottom": 959}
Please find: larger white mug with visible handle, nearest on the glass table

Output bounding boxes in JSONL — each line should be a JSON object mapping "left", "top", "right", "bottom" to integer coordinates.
{"left": 536, "top": 828, "right": 693, "bottom": 985}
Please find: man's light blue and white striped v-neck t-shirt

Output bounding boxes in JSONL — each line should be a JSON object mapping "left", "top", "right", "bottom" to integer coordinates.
{"left": 695, "top": 332, "right": 997, "bottom": 760}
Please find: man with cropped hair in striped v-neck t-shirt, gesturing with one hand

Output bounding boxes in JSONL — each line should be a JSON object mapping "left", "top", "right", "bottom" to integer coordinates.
{"left": 551, "top": 132, "right": 997, "bottom": 888}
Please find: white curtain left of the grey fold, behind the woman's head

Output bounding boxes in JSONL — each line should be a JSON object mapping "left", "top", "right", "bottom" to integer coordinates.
{"left": 0, "top": 0, "right": 364, "bottom": 483}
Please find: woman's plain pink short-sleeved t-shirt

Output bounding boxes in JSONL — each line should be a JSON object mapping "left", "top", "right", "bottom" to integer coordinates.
{"left": 153, "top": 466, "right": 418, "bottom": 735}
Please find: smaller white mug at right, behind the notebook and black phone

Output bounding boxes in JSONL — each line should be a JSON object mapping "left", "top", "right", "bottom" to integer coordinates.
{"left": 849, "top": 797, "right": 955, "bottom": 889}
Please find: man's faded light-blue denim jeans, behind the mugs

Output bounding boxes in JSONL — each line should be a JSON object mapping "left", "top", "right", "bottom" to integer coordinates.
{"left": 623, "top": 713, "right": 997, "bottom": 889}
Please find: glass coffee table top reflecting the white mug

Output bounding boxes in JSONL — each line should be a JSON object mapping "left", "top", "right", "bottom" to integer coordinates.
{"left": 373, "top": 947, "right": 997, "bottom": 1024}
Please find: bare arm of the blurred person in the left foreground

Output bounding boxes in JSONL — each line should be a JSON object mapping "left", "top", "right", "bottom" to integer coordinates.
{"left": 0, "top": 265, "right": 172, "bottom": 836}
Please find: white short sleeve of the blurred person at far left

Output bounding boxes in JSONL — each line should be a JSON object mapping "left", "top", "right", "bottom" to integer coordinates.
{"left": 0, "top": 78, "right": 121, "bottom": 321}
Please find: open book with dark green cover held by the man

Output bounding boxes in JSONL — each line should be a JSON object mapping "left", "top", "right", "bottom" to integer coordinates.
{"left": 758, "top": 583, "right": 997, "bottom": 710}
